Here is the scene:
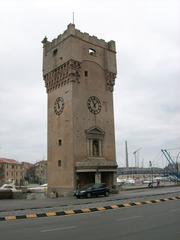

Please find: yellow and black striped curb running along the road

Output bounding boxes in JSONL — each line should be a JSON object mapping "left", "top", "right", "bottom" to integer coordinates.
{"left": 0, "top": 196, "right": 180, "bottom": 221}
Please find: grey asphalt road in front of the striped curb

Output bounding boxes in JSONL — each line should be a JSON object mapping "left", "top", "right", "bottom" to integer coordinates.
{"left": 0, "top": 200, "right": 180, "bottom": 240}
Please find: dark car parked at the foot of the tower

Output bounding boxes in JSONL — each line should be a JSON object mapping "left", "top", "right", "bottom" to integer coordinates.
{"left": 74, "top": 183, "right": 109, "bottom": 198}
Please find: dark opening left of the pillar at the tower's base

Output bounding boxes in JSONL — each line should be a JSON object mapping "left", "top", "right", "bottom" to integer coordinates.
{"left": 76, "top": 172, "right": 95, "bottom": 188}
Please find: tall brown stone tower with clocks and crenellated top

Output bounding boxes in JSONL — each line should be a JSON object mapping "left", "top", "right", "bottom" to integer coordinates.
{"left": 42, "top": 24, "right": 117, "bottom": 196}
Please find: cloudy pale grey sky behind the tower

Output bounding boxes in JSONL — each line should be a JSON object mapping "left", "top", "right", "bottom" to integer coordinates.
{"left": 0, "top": 0, "right": 180, "bottom": 166}
